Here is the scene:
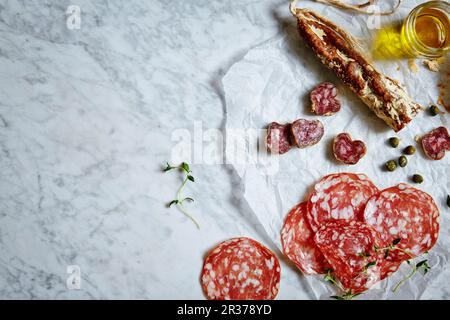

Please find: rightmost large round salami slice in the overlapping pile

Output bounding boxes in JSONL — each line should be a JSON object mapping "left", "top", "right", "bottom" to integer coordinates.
{"left": 364, "top": 183, "right": 439, "bottom": 261}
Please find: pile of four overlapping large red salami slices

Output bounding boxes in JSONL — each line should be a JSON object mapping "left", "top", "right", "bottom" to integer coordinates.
{"left": 281, "top": 173, "right": 439, "bottom": 294}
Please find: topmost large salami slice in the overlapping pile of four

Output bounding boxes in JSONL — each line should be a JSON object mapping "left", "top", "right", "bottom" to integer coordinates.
{"left": 307, "top": 173, "right": 378, "bottom": 232}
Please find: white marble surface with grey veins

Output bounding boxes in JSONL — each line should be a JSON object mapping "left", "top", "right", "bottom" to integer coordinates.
{"left": 0, "top": 0, "right": 450, "bottom": 299}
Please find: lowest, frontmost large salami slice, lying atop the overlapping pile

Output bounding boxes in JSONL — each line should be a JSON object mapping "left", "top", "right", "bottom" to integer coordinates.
{"left": 314, "top": 220, "right": 384, "bottom": 294}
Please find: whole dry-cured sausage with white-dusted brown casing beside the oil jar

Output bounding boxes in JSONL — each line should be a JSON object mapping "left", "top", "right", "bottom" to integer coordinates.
{"left": 290, "top": 1, "right": 422, "bottom": 132}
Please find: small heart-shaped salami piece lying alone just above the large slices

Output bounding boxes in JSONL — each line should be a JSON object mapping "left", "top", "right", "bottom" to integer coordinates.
{"left": 333, "top": 133, "right": 366, "bottom": 164}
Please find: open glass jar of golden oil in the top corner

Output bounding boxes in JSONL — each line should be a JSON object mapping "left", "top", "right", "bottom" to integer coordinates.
{"left": 401, "top": 1, "right": 450, "bottom": 58}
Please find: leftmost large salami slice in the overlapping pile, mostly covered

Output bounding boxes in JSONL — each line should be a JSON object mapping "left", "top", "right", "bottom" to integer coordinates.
{"left": 281, "top": 202, "right": 330, "bottom": 274}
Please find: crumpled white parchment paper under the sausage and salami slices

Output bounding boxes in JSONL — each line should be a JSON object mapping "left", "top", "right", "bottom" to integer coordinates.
{"left": 223, "top": 1, "right": 450, "bottom": 299}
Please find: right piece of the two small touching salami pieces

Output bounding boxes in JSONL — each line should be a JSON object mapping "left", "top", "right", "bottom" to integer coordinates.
{"left": 291, "top": 119, "right": 324, "bottom": 148}
